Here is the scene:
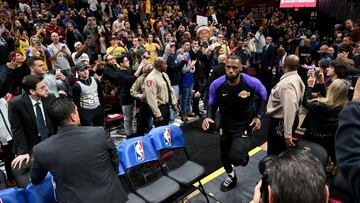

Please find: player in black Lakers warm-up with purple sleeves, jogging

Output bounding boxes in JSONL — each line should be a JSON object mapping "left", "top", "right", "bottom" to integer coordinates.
{"left": 202, "top": 56, "right": 267, "bottom": 192}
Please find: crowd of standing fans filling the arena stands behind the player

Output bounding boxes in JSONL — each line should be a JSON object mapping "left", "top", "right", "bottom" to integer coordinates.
{"left": 0, "top": 0, "right": 360, "bottom": 201}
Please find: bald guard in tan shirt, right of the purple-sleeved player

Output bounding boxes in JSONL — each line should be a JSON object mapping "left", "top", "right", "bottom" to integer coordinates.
{"left": 267, "top": 55, "right": 305, "bottom": 154}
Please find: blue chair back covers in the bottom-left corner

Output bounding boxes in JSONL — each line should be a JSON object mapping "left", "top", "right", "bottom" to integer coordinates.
{"left": 0, "top": 173, "right": 57, "bottom": 203}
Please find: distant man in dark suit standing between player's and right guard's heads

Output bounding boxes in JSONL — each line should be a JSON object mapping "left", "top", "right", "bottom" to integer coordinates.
{"left": 259, "top": 36, "right": 276, "bottom": 93}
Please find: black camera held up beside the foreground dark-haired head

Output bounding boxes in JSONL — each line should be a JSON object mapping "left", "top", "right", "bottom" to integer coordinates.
{"left": 258, "top": 155, "right": 274, "bottom": 203}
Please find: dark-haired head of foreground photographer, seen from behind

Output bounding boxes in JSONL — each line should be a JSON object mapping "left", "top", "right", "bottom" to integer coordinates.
{"left": 252, "top": 149, "right": 329, "bottom": 203}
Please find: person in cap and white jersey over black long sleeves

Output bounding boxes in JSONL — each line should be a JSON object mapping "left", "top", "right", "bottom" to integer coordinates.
{"left": 73, "top": 62, "right": 104, "bottom": 126}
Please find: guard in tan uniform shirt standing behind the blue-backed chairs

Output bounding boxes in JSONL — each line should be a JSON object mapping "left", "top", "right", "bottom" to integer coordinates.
{"left": 145, "top": 57, "right": 179, "bottom": 127}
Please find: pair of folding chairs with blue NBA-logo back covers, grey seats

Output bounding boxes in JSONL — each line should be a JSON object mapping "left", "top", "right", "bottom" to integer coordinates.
{"left": 117, "top": 125, "right": 209, "bottom": 203}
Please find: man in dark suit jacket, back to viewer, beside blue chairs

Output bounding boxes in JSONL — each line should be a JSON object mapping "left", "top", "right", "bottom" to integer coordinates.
{"left": 31, "top": 97, "right": 127, "bottom": 203}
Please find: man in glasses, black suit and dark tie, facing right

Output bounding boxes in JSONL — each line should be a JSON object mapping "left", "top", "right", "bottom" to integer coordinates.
{"left": 9, "top": 75, "right": 56, "bottom": 168}
